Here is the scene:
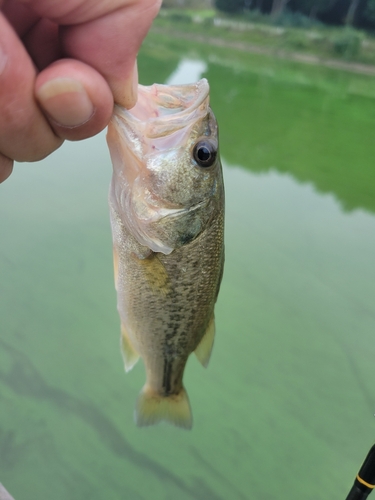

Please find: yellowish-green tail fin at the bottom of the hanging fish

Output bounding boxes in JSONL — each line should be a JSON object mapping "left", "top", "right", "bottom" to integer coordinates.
{"left": 135, "top": 386, "right": 193, "bottom": 429}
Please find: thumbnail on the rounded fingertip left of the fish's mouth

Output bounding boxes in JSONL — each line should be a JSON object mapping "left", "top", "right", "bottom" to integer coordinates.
{"left": 36, "top": 78, "right": 94, "bottom": 127}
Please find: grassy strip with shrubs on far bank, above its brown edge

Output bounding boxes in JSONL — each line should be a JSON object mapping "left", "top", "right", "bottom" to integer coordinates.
{"left": 155, "top": 9, "right": 375, "bottom": 65}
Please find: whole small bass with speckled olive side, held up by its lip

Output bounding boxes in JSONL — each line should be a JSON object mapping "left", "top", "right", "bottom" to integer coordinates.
{"left": 107, "top": 79, "right": 225, "bottom": 429}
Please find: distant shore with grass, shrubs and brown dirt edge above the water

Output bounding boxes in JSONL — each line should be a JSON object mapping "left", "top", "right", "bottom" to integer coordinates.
{"left": 152, "top": 9, "right": 375, "bottom": 76}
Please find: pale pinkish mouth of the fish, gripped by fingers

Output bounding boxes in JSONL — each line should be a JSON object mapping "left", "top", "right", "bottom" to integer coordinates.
{"left": 115, "top": 78, "right": 210, "bottom": 139}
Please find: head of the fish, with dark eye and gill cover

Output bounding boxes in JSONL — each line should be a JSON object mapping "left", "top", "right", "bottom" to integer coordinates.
{"left": 107, "top": 79, "right": 223, "bottom": 254}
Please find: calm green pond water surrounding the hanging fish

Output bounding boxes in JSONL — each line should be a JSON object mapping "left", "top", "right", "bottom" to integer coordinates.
{"left": 0, "top": 31, "right": 375, "bottom": 500}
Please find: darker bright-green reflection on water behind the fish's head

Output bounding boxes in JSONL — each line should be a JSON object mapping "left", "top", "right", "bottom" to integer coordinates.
{"left": 140, "top": 47, "right": 375, "bottom": 217}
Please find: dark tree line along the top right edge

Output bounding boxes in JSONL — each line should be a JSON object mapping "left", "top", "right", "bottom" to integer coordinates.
{"left": 215, "top": 0, "right": 375, "bottom": 29}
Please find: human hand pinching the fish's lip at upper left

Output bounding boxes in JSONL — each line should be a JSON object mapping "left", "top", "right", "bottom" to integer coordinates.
{"left": 0, "top": 0, "right": 161, "bottom": 182}
